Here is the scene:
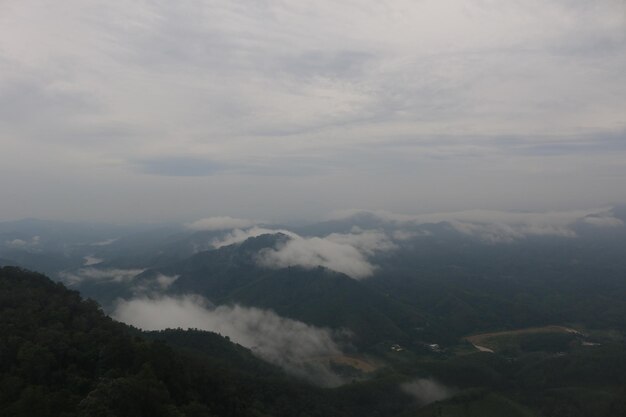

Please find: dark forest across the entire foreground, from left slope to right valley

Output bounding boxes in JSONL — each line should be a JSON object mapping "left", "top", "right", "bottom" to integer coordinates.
{"left": 0, "top": 267, "right": 626, "bottom": 417}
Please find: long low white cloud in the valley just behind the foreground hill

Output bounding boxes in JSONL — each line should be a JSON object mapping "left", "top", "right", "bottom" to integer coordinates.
{"left": 113, "top": 296, "right": 343, "bottom": 386}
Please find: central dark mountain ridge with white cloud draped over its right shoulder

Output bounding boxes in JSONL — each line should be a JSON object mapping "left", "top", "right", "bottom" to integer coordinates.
{"left": 143, "top": 234, "right": 423, "bottom": 348}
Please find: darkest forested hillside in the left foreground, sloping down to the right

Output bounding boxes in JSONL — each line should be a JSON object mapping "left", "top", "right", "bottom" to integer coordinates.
{"left": 0, "top": 267, "right": 346, "bottom": 417}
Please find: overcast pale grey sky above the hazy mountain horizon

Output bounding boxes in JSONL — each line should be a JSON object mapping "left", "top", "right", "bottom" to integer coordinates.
{"left": 0, "top": 0, "right": 626, "bottom": 222}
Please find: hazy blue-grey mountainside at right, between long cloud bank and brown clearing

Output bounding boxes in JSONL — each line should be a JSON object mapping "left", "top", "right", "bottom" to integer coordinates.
{"left": 368, "top": 227, "right": 626, "bottom": 343}
